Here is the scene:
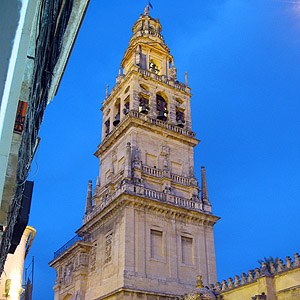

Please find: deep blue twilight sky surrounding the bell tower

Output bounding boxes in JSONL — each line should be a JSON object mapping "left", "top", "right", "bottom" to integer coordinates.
{"left": 29, "top": 0, "right": 300, "bottom": 300}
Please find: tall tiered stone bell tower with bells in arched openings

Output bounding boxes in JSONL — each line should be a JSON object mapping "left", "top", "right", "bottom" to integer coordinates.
{"left": 50, "top": 6, "right": 218, "bottom": 300}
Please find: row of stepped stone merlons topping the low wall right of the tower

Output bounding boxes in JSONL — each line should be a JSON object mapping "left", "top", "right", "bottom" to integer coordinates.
{"left": 208, "top": 253, "right": 300, "bottom": 293}
